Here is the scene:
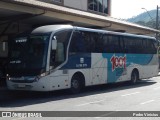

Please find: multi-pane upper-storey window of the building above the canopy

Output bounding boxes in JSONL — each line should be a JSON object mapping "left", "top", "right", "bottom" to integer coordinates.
{"left": 88, "top": 0, "right": 108, "bottom": 14}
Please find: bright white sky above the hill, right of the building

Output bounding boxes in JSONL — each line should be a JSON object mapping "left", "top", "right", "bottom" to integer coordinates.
{"left": 111, "top": 0, "right": 160, "bottom": 19}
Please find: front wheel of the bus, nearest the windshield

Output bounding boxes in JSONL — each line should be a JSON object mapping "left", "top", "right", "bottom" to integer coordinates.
{"left": 70, "top": 76, "right": 82, "bottom": 94}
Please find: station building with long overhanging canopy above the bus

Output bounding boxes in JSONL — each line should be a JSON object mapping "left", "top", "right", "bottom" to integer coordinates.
{"left": 0, "top": 0, "right": 159, "bottom": 86}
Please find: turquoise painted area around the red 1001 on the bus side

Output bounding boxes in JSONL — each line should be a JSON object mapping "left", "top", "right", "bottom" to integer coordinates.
{"left": 102, "top": 53, "right": 153, "bottom": 83}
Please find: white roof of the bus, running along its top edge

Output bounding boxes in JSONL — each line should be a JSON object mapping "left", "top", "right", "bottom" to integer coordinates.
{"left": 32, "top": 25, "right": 155, "bottom": 39}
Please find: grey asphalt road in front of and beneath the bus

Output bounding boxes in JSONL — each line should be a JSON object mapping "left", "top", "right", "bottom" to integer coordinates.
{"left": 0, "top": 76, "right": 160, "bottom": 120}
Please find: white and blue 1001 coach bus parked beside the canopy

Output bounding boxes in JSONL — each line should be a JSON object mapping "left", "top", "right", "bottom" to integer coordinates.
{"left": 6, "top": 25, "right": 158, "bottom": 93}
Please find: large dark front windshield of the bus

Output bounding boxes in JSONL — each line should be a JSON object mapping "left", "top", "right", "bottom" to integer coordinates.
{"left": 8, "top": 35, "right": 50, "bottom": 75}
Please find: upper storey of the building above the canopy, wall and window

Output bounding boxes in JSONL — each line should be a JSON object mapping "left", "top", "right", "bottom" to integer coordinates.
{"left": 38, "top": 0, "right": 111, "bottom": 15}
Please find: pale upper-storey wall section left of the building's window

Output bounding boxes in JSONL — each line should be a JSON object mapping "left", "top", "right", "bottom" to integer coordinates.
{"left": 64, "top": 0, "right": 88, "bottom": 11}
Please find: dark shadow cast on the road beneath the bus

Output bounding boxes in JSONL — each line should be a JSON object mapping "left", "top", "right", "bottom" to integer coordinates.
{"left": 0, "top": 80, "right": 156, "bottom": 108}
